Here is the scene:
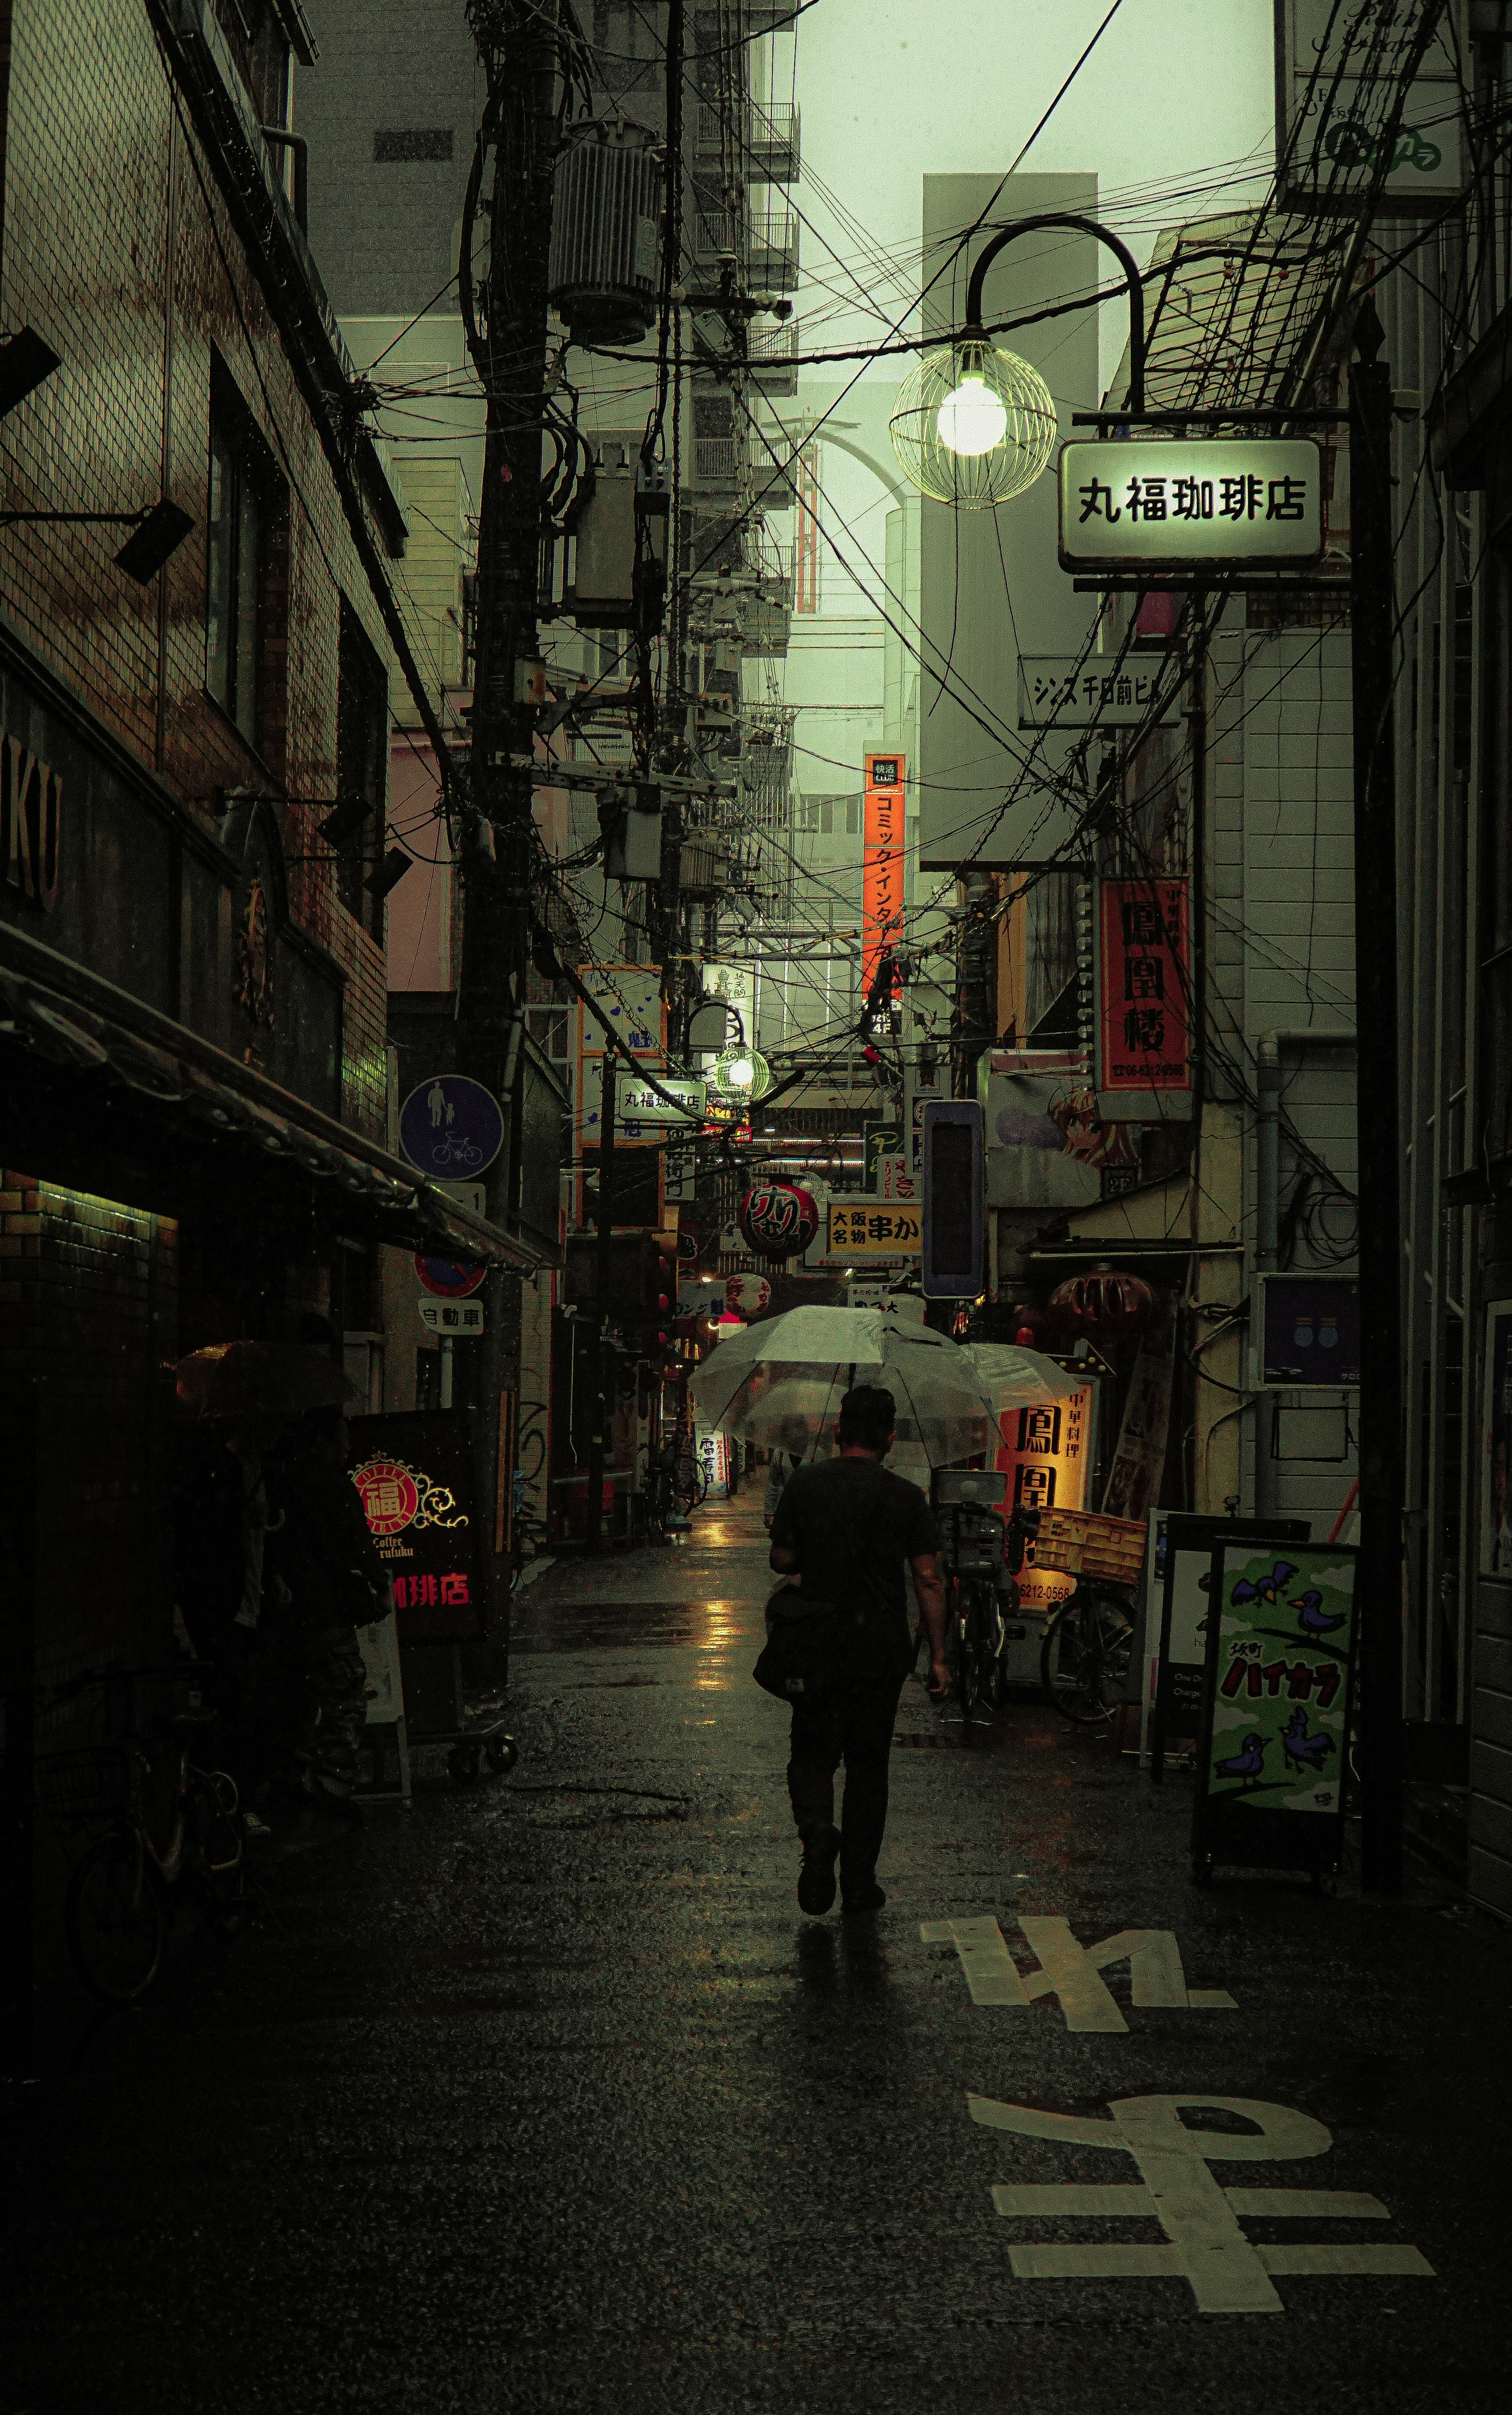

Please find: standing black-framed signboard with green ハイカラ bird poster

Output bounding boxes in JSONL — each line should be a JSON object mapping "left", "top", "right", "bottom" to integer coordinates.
{"left": 1191, "top": 1536, "right": 1360, "bottom": 1881}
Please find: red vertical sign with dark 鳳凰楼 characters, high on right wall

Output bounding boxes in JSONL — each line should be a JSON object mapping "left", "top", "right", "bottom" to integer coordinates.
{"left": 1097, "top": 882, "right": 1191, "bottom": 1092}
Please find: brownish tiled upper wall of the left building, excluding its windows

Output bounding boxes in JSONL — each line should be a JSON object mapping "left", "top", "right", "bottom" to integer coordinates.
{"left": 0, "top": 0, "right": 386, "bottom": 1138}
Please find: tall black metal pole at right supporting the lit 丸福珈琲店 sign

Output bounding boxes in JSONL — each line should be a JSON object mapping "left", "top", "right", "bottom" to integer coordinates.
{"left": 1350, "top": 297, "right": 1406, "bottom": 1896}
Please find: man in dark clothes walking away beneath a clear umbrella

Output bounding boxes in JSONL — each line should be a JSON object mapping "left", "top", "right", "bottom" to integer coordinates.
{"left": 771, "top": 1384, "right": 949, "bottom": 1913}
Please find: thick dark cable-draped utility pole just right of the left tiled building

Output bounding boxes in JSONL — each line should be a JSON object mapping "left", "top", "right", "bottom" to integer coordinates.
{"left": 456, "top": 0, "right": 558, "bottom": 1606}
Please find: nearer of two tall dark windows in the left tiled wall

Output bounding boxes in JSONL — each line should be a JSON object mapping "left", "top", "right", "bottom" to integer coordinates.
{"left": 205, "top": 369, "right": 278, "bottom": 746}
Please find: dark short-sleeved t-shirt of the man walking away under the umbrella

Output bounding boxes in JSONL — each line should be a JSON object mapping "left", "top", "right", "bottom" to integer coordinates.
{"left": 773, "top": 1459, "right": 939, "bottom": 1669}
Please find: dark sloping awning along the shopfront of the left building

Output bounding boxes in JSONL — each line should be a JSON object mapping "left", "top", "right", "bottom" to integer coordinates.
{"left": 0, "top": 925, "right": 551, "bottom": 1273}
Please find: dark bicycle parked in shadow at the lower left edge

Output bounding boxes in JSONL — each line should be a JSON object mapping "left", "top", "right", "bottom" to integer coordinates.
{"left": 36, "top": 1669, "right": 241, "bottom": 2004}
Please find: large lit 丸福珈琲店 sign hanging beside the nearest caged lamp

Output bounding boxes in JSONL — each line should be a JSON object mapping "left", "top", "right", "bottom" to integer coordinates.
{"left": 1060, "top": 437, "right": 1324, "bottom": 577}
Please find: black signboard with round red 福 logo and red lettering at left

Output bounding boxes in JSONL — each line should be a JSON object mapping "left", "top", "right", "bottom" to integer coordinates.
{"left": 350, "top": 1410, "right": 485, "bottom": 1645}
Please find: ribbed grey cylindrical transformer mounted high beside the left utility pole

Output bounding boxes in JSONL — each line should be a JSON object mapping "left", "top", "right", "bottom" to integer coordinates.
{"left": 548, "top": 119, "right": 662, "bottom": 345}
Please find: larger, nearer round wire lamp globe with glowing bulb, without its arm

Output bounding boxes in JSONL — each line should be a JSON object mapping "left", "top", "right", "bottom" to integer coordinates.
{"left": 886, "top": 335, "right": 1056, "bottom": 512}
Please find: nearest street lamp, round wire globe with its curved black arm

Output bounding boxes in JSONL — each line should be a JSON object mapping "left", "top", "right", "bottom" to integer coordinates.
{"left": 886, "top": 215, "right": 1145, "bottom": 512}
